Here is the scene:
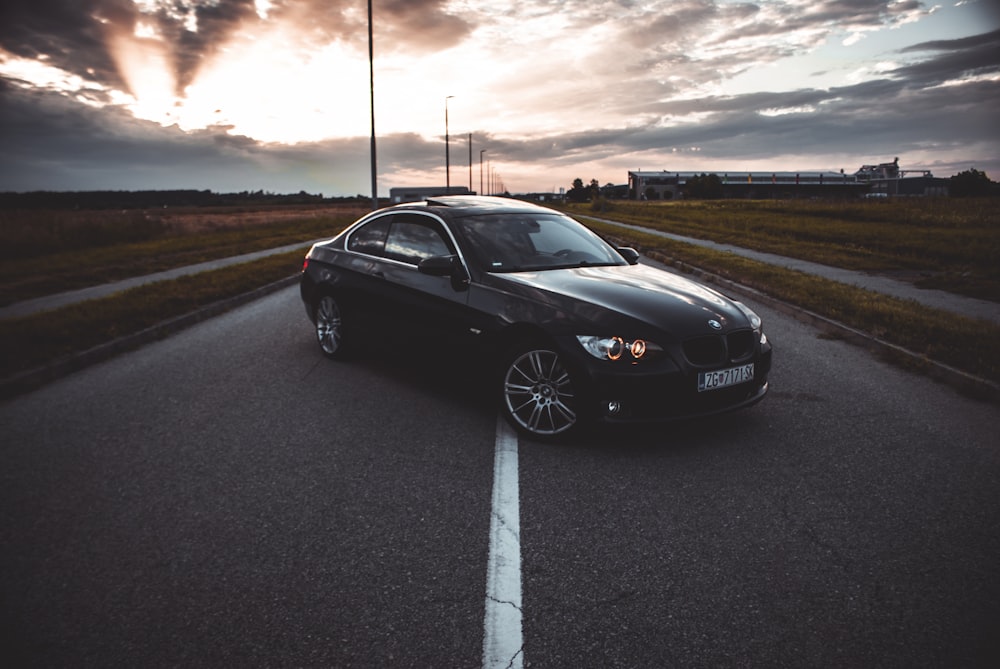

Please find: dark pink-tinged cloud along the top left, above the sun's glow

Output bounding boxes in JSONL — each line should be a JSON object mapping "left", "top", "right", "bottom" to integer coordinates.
{"left": 0, "top": 0, "right": 472, "bottom": 95}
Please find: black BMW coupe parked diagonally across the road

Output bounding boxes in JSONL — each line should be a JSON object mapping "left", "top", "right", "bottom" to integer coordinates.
{"left": 301, "top": 196, "right": 771, "bottom": 438}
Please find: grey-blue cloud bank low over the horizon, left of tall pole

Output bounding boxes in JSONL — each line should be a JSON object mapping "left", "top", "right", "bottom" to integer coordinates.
{"left": 0, "top": 81, "right": 370, "bottom": 195}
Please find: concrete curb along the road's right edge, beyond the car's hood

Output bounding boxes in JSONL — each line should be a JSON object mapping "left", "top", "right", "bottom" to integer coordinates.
{"left": 615, "top": 239, "right": 1000, "bottom": 404}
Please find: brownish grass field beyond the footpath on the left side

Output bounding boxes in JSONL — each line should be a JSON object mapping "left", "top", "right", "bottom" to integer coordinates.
{"left": 0, "top": 206, "right": 364, "bottom": 306}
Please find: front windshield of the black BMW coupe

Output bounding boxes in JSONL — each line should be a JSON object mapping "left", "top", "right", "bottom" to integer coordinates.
{"left": 454, "top": 213, "right": 627, "bottom": 272}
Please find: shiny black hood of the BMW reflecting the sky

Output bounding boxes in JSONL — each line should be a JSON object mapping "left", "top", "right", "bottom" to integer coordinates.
{"left": 498, "top": 265, "right": 750, "bottom": 339}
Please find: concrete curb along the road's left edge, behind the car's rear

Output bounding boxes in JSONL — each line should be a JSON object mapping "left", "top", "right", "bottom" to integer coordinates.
{"left": 0, "top": 274, "right": 299, "bottom": 400}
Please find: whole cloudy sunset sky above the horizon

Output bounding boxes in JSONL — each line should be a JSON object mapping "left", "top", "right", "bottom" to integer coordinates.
{"left": 0, "top": 0, "right": 1000, "bottom": 197}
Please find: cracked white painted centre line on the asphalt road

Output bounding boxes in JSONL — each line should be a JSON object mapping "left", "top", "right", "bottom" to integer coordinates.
{"left": 483, "top": 416, "right": 524, "bottom": 669}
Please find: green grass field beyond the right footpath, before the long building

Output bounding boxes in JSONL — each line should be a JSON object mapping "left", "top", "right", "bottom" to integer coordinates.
{"left": 568, "top": 198, "right": 1000, "bottom": 301}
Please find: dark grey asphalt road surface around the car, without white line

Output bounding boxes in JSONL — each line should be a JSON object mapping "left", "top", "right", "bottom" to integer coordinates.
{"left": 0, "top": 288, "right": 1000, "bottom": 668}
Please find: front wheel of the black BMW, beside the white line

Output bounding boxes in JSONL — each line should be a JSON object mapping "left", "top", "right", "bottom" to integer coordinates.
{"left": 501, "top": 345, "right": 580, "bottom": 440}
